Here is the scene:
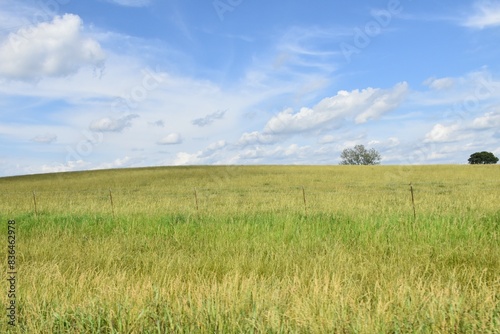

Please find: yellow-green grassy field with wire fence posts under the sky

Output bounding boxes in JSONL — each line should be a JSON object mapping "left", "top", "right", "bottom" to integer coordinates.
{"left": 0, "top": 165, "right": 500, "bottom": 333}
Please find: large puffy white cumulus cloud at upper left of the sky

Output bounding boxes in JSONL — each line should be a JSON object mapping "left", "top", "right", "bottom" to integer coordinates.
{"left": 0, "top": 14, "right": 106, "bottom": 80}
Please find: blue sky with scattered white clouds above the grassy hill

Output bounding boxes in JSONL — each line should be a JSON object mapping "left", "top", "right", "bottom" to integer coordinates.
{"left": 0, "top": 0, "right": 500, "bottom": 176}
